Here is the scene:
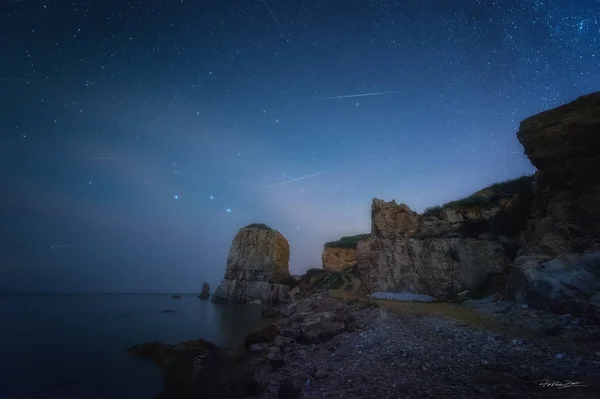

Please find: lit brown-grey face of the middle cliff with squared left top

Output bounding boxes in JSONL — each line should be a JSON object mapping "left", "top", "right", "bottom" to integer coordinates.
{"left": 356, "top": 199, "right": 508, "bottom": 300}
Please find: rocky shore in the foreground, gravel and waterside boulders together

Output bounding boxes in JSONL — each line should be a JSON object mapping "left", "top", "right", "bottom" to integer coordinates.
{"left": 129, "top": 293, "right": 600, "bottom": 399}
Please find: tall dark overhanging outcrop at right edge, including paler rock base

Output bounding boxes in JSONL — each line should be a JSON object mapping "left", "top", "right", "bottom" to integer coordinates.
{"left": 509, "top": 92, "right": 600, "bottom": 314}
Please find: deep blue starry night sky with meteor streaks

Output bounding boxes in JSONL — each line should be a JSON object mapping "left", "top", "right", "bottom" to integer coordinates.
{"left": 0, "top": 0, "right": 600, "bottom": 292}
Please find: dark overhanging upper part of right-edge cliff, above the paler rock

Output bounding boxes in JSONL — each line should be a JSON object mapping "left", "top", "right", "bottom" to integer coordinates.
{"left": 517, "top": 92, "right": 600, "bottom": 255}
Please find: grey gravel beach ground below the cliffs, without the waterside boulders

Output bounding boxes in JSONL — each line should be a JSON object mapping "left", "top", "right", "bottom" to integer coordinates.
{"left": 251, "top": 301, "right": 600, "bottom": 399}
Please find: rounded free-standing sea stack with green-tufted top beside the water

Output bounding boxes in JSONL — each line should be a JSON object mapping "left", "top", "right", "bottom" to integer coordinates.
{"left": 212, "top": 225, "right": 290, "bottom": 303}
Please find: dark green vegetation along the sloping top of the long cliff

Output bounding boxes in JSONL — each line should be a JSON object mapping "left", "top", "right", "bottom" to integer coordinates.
{"left": 423, "top": 175, "right": 533, "bottom": 215}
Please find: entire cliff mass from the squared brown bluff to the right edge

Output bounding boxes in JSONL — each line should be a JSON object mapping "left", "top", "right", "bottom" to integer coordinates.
{"left": 356, "top": 92, "right": 600, "bottom": 313}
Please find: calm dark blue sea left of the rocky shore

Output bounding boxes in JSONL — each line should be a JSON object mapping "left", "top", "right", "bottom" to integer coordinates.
{"left": 0, "top": 295, "right": 263, "bottom": 399}
